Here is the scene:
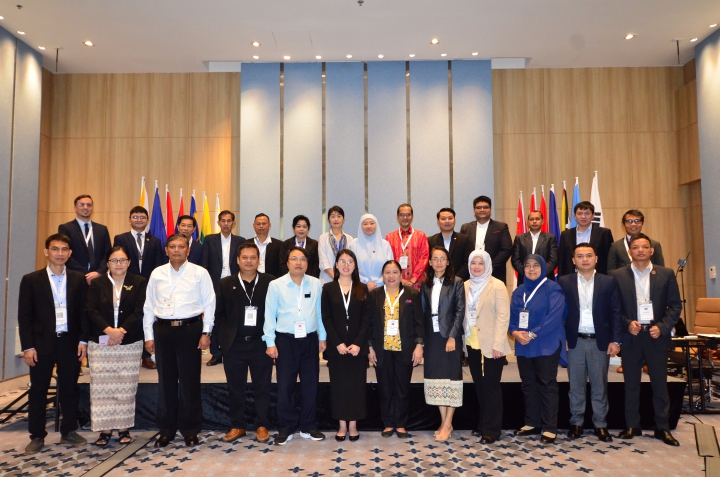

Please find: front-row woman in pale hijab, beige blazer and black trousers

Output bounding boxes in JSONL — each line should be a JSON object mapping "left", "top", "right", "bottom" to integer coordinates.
{"left": 464, "top": 250, "right": 510, "bottom": 444}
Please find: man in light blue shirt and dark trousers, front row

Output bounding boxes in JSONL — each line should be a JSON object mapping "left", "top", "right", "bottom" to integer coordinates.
{"left": 263, "top": 247, "right": 326, "bottom": 445}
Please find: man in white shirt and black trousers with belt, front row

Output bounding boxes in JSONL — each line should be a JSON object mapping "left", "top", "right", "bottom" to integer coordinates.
{"left": 143, "top": 234, "right": 215, "bottom": 447}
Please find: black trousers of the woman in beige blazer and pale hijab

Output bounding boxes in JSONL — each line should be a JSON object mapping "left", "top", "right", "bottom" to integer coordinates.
{"left": 467, "top": 346, "right": 505, "bottom": 439}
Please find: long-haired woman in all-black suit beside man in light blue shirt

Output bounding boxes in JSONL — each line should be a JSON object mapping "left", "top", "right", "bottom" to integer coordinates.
{"left": 322, "top": 249, "right": 370, "bottom": 442}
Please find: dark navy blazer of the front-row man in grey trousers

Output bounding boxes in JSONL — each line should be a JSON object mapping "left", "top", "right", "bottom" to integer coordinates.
{"left": 558, "top": 273, "right": 622, "bottom": 351}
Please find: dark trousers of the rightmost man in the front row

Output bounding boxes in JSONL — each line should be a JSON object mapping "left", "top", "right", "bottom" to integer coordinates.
{"left": 622, "top": 331, "right": 670, "bottom": 431}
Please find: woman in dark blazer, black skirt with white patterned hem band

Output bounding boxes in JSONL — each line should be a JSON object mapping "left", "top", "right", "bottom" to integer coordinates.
{"left": 420, "top": 247, "right": 465, "bottom": 441}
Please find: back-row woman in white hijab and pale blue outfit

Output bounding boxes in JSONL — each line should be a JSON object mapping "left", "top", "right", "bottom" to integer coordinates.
{"left": 348, "top": 214, "right": 393, "bottom": 291}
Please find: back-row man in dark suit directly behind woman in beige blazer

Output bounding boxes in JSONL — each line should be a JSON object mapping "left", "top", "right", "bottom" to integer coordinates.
{"left": 460, "top": 195, "right": 512, "bottom": 283}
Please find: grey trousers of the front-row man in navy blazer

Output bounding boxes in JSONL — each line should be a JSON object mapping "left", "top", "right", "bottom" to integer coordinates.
{"left": 568, "top": 338, "right": 610, "bottom": 428}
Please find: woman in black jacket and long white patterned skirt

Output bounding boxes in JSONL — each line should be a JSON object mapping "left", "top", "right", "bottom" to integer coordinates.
{"left": 85, "top": 247, "right": 147, "bottom": 447}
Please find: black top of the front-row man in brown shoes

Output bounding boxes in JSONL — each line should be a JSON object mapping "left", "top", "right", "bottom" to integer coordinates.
{"left": 213, "top": 273, "right": 275, "bottom": 356}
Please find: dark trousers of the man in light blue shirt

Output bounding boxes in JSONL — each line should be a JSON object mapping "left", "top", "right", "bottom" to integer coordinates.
{"left": 275, "top": 333, "right": 320, "bottom": 435}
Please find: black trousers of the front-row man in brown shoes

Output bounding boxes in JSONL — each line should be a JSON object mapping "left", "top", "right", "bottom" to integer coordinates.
{"left": 223, "top": 336, "right": 272, "bottom": 429}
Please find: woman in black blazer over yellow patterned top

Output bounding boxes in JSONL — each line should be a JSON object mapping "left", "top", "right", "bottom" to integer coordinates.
{"left": 368, "top": 260, "right": 424, "bottom": 438}
